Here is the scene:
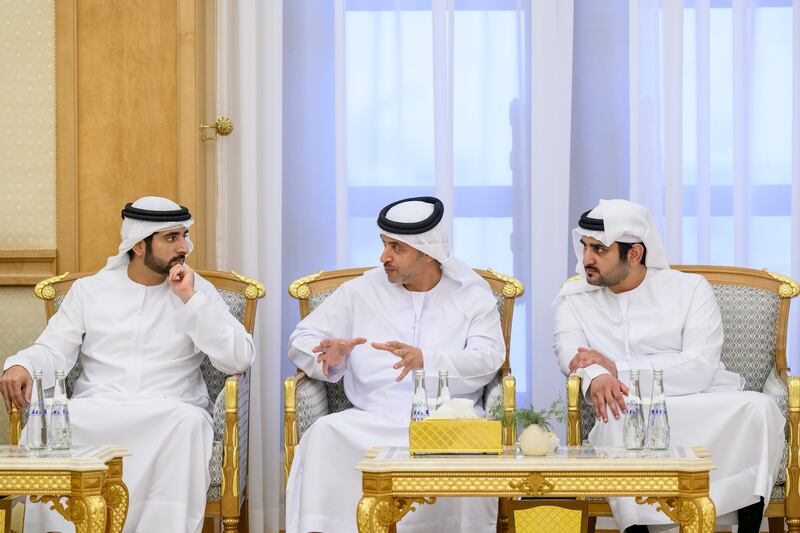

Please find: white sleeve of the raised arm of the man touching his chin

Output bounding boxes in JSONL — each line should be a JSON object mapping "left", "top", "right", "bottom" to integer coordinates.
{"left": 181, "top": 279, "right": 256, "bottom": 374}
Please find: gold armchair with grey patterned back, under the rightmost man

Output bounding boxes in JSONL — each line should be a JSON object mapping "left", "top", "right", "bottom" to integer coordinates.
{"left": 567, "top": 265, "right": 800, "bottom": 532}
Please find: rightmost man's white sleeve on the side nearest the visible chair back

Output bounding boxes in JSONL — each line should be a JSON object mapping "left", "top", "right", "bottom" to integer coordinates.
{"left": 617, "top": 279, "right": 723, "bottom": 396}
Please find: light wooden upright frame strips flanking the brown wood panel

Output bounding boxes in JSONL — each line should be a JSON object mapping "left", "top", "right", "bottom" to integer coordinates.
{"left": 55, "top": 0, "right": 215, "bottom": 272}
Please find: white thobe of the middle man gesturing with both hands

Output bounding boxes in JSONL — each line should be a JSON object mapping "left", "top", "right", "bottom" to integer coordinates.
{"left": 286, "top": 269, "right": 505, "bottom": 533}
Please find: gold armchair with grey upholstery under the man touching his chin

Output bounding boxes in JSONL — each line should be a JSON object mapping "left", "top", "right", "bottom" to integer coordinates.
{"left": 10, "top": 271, "right": 264, "bottom": 532}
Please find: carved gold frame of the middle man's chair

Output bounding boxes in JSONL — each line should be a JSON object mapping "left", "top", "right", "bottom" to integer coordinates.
{"left": 283, "top": 267, "right": 525, "bottom": 524}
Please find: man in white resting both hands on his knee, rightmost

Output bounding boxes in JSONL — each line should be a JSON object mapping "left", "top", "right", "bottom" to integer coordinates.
{"left": 554, "top": 200, "right": 785, "bottom": 533}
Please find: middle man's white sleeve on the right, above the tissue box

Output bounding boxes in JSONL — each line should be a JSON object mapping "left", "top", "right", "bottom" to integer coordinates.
{"left": 420, "top": 297, "right": 506, "bottom": 394}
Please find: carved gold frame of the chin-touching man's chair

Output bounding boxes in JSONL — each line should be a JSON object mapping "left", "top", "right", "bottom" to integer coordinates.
{"left": 10, "top": 270, "right": 265, "bottom": 532}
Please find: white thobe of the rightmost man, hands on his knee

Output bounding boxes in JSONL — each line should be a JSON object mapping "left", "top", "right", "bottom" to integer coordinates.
{"left": 554, "top": 269, "right": 785, "bottom": 529}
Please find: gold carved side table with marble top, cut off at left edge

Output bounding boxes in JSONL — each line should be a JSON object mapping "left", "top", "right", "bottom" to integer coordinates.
{"left": 0, "top": 445, "right": 130, "bottom": 533}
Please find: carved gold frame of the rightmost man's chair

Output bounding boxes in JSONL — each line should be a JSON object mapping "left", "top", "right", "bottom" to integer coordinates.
{"left": 567, "top": 265, "right": 800, "bottom": 533}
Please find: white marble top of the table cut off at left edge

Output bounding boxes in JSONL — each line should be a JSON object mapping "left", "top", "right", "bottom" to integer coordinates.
{"left": 0, "top": 445, "right": 130, "bottom": 472}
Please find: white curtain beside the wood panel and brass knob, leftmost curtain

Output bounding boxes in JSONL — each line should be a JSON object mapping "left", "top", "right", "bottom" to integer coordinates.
{"left": 217, "top": 0, "right": 285, "bottom": 532}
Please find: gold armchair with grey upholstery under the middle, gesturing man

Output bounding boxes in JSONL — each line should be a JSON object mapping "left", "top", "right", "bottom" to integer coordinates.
{"left": 283, "top": 267, "right": 525, "bottom": 524}
